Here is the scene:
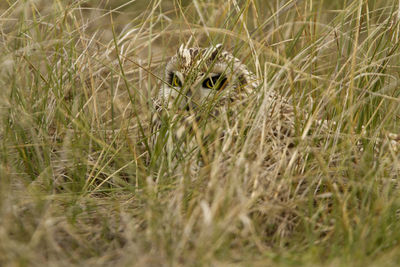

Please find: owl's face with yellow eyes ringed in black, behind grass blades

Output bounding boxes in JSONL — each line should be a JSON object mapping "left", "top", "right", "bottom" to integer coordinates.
{"left": 159, "top": 44, "right": 255, "bottom": 110}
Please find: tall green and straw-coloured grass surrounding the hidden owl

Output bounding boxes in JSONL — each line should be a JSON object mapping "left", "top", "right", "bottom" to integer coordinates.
{"left": 0, "top": 0, "right": 400, "bottom": 266}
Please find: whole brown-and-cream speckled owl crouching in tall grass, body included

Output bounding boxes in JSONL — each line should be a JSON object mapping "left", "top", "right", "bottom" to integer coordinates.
{"left": 150, "top": 44, "right": 400, "bottom": 173}
